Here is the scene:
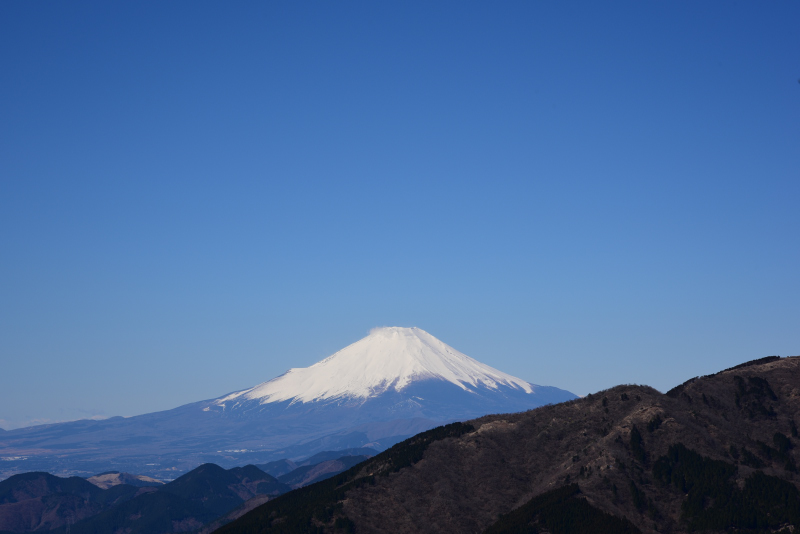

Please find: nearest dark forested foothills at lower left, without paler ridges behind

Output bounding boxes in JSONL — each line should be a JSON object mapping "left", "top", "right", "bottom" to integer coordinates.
{"left": 0, "top": 464, "right": 290, "bottom": 534}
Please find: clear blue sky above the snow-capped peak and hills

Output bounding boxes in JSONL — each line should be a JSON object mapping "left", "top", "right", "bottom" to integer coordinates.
{"left": 0, "top": 1, "right": 800, "bottom": 428}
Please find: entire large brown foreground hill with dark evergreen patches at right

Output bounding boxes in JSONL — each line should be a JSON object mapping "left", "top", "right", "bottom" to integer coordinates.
{"left": 220, "top": 357, "right": 800, "bottom": 534}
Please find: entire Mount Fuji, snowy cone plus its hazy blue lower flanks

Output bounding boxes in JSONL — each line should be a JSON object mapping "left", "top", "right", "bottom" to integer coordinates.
{"left": 0, "top": 327, "right": 576, "bottom": 479}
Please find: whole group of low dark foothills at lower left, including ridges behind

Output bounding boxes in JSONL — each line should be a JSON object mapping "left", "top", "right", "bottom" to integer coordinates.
{"left": 0, "top": 449, "right": 377, "bottom": 534}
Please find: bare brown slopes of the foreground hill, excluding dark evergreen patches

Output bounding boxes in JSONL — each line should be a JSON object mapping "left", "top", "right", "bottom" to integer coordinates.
{"left": 336, "top": 357, "right": 800, "bottom": 533}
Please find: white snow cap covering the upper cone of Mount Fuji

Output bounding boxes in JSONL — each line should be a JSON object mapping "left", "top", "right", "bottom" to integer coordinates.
{"left": 215, "top": 327, "right": 534, "bottom": 405}
